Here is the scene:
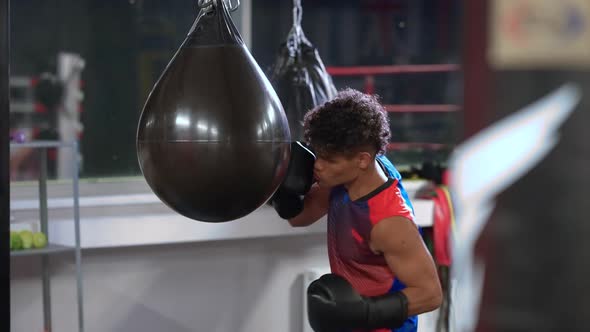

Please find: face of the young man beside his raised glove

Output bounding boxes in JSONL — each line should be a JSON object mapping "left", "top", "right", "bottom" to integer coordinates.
{"left": 314, "top": 153, "right": 360, "bottom": 187}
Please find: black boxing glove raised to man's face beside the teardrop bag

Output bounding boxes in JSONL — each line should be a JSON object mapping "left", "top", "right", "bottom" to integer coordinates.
{"left": 270, "top": 141, "right": 315, "bottom": 219}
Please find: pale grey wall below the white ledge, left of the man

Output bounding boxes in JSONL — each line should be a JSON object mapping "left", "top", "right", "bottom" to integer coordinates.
{"left": 11, "top": 234, "right": 327, "bottom": 332}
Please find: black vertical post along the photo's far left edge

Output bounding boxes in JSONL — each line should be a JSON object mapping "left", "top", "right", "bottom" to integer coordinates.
{"left": 0, "top": 0, "right": 10, "bottom": 331}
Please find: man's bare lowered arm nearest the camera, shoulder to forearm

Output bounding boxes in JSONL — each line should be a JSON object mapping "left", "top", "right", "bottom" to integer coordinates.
{"left": 370, "top": 217, "right": 442, "bottom": 316}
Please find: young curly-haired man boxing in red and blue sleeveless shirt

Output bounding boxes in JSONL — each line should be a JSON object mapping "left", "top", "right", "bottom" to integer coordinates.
{"left": 272, "top": 89, "right": 442, "bottom": 332}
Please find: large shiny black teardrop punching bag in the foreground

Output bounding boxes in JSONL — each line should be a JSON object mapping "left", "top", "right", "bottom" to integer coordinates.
{"left": 137, "top": 0, "right": 291, "bottom": 222}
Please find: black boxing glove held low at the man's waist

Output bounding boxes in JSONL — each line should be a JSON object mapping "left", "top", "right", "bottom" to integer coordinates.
{"left": 307, "top": 274, "right": 408, "bottom": 332}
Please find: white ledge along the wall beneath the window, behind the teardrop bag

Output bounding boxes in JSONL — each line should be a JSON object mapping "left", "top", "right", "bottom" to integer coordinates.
{"left": 41, "top": 200, "right": 434, "bottom": 248}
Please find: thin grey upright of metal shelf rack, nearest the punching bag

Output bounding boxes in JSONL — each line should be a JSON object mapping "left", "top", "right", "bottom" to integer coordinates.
{"left": 72, "top": 141, "right": 84, "bottom": 332}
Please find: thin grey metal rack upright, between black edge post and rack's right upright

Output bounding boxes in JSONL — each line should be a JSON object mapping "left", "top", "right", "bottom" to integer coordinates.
{"left": 39, "top": 148, "right": 51, "bottom": 332}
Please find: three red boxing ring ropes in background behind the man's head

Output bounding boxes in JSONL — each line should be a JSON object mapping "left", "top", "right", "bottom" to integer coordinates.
{"left": 326, "top": 63, "right": 461, "bottom": 151}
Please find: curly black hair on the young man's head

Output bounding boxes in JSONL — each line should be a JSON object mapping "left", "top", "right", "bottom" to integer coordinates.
{"left": 303, "top": 88, "right": 391, "bottom": 155}
